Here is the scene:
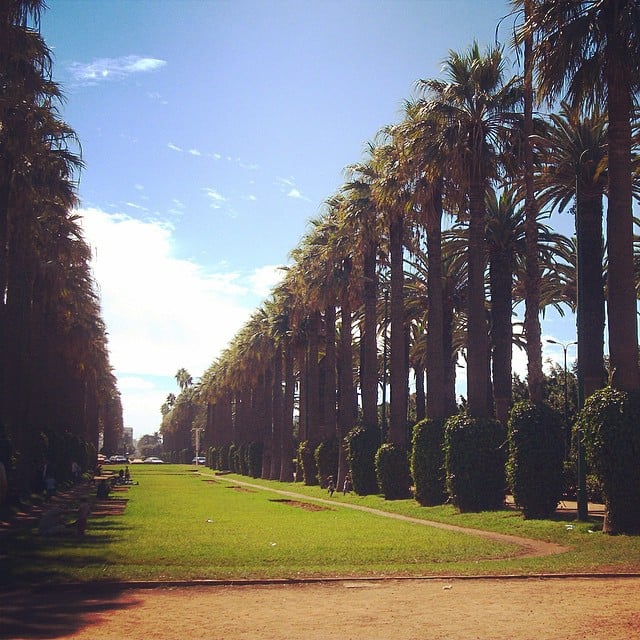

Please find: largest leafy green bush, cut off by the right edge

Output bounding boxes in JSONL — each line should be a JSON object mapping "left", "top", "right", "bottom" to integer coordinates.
{"left": 576, "top": 387, "right": 640, "bottom": 535}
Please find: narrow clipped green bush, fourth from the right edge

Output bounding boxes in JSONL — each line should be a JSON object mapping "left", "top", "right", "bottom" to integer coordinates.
{"left": 411, "top": 418, "right": 447, "bottom": 506}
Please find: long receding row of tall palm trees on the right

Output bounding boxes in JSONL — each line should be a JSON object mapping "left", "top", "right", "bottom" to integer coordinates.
{"left": 163, "top": 0, "right": 640, "bottom": 504}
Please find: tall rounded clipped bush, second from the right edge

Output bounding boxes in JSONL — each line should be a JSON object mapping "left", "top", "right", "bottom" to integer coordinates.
{"left": 507, "top": 400, "right": 564, "bottom": 518}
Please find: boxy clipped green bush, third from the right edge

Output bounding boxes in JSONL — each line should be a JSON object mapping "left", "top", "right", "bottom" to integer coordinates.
{"left": 444, "top": 413, "right": 506, "bottom": 512}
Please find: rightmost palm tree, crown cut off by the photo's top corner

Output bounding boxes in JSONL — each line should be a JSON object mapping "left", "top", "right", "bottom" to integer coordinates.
{"left": 518, "top": 0, "right": 640, "bottom": 391}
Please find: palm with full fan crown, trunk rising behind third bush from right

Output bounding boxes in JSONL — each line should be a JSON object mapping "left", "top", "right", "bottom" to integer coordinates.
{"left": 420, "top": 43, "right": 522, "bottom": 417}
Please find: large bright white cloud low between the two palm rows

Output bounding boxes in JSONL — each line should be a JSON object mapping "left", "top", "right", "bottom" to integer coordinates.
{"left": 79, "top": 209, "right": 264, "bottom": 437}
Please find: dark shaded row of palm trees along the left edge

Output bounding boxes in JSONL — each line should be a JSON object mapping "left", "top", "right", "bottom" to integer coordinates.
{"left": 0, "top": 0, "right": 122, "bottom": 495}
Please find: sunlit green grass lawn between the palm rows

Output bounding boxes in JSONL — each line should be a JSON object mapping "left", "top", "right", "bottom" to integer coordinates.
{"left": 9, "top": 464, "right": 640, "bottom": 583}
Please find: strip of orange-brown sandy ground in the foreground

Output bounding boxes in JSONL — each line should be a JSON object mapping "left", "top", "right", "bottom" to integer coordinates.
{"left": 0, "top": 577, "right": 640, "bottom": 640}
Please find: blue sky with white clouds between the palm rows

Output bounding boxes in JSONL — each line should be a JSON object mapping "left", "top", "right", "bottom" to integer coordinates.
{"left": 41, "top": 0, "right": 573, "bottom": 437}
